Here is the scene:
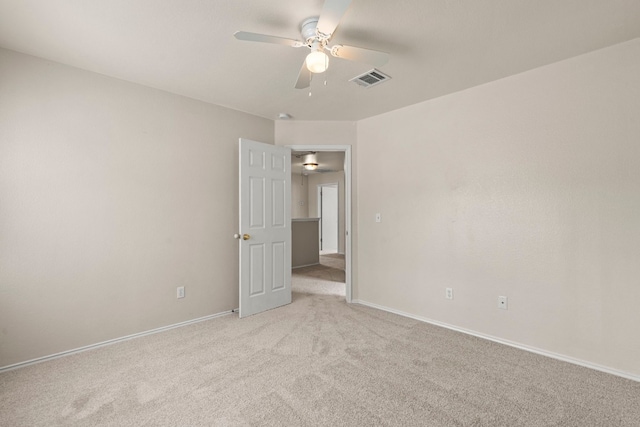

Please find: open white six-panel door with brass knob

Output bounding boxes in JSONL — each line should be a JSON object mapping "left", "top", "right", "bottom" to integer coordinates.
{"left": 236, "top": 138, "right": 291, "bottom": 317}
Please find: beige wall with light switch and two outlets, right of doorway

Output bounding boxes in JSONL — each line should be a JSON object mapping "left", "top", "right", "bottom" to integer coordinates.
{"left": 357, "top": 39, "right": 640, "bottom": 375}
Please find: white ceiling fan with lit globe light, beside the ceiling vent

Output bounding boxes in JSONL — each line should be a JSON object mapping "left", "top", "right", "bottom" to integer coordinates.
{"left": 234, "top": 0, "right": 389, "bottom": 89}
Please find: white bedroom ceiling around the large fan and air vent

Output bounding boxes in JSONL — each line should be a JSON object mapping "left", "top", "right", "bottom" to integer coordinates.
{"left": 0, "top": 0, "right": 640, "bottom": 120}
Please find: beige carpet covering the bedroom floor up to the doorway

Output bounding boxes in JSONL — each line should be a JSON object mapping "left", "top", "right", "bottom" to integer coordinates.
{"left": 0, "top": 266, "right": 640, "bottom": 427}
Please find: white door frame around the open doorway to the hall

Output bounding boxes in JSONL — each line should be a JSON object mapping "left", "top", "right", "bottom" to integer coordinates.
{"left": 286, "top": 144, "right": 353, "bottom": 303}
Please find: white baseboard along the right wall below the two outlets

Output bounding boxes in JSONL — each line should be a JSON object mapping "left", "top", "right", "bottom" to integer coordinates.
{"left": 352, "top": 299, "right": 640, "bottom": 382}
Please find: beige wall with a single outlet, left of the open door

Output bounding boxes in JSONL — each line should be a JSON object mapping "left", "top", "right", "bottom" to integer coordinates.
{"left": 0, "top": 50, "right": 274, "bottom": 366}
